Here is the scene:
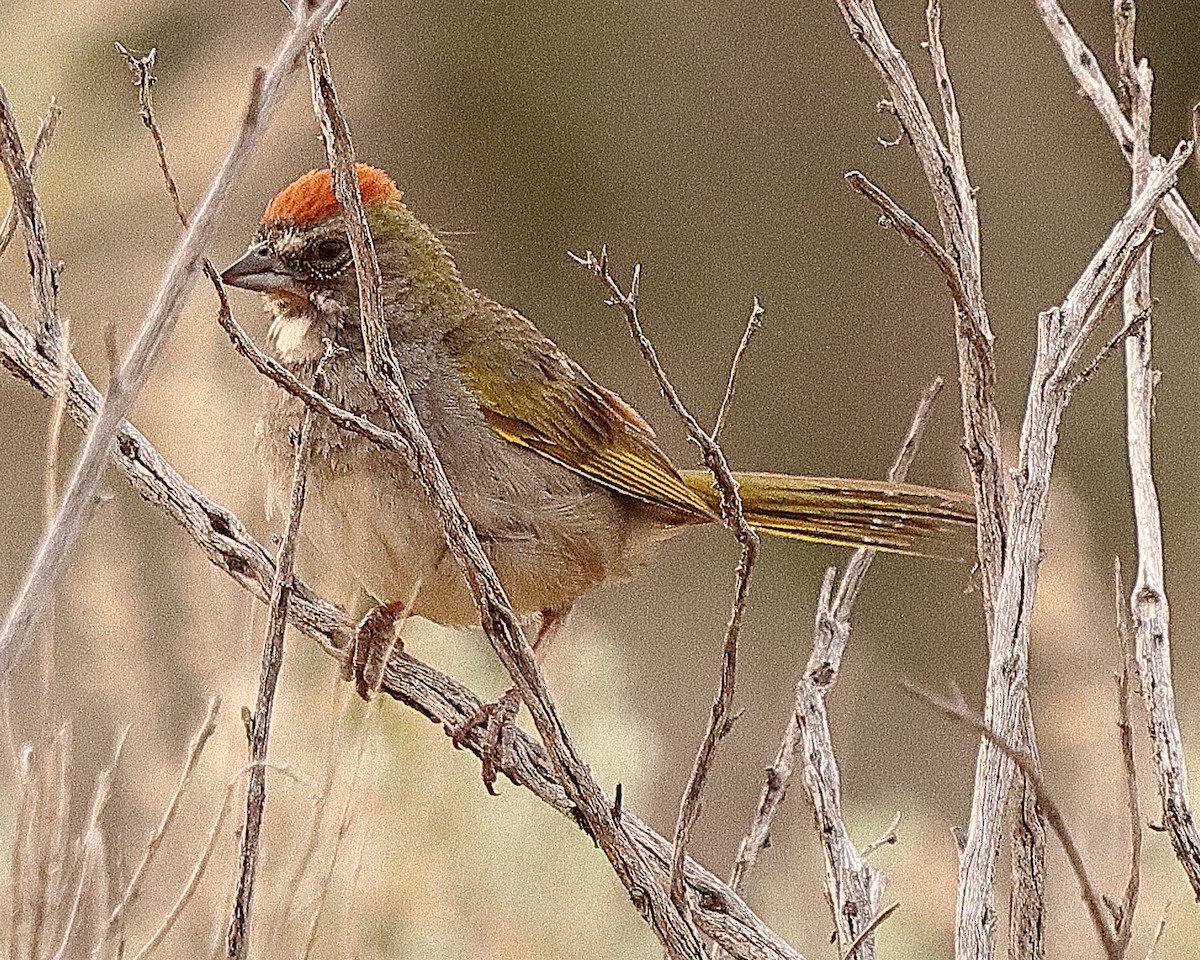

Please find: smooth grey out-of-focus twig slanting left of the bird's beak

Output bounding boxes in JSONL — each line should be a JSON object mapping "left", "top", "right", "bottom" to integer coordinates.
{"left": 0, "top": 0, "right": 344, "bottom": 674}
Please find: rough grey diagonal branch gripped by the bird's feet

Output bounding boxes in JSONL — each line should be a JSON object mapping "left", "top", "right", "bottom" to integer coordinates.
{"left": 0, "top": 296, "right": 798, "bottom": 960}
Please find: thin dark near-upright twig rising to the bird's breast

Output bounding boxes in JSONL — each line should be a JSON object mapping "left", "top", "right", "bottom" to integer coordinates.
{"left": 227, "top": 379, "right": 319, "bottom": 960}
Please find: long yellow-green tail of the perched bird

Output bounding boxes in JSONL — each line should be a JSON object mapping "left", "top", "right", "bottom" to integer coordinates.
{"left": 680, "top": 470, "right": 974, "bottom": 560}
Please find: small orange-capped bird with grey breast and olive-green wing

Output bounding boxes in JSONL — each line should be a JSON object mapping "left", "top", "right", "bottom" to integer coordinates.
{"left": 221, "top": 164, "right": 974, "bottom": 777}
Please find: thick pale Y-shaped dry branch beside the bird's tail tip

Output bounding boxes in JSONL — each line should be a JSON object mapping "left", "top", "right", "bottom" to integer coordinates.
{"left": 839, "top": 0, "right": 1192, "bottom": 960}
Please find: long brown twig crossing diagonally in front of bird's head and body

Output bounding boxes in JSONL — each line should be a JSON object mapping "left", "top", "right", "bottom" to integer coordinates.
{"left": 308, "top": 40, "right": 703, "bottom": 960}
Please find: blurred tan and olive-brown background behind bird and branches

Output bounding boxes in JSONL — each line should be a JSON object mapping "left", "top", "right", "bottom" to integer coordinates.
{"left": 0, "top": 0, "right": 1200, "bottom": 960}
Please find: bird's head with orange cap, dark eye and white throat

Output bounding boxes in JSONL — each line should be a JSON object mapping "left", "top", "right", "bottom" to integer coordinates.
{"left": 221, "top": 163, "right": 462, "bottom": 360}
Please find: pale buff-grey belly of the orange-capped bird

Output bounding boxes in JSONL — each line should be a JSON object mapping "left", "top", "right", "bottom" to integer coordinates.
{"left": 260, "top": 405, "right": 676, "bottom": 625}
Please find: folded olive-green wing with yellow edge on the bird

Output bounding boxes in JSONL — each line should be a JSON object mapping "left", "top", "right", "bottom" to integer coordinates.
{"left": 451, "top": 308, "right": 715, "bottom": 520}
